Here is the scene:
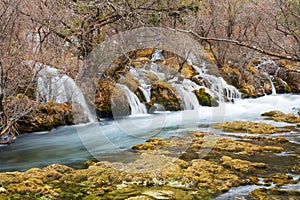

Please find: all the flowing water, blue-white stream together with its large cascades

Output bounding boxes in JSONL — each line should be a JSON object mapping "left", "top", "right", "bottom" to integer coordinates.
{"left": 0, "top": 58, "right": 300, "bottom": 199}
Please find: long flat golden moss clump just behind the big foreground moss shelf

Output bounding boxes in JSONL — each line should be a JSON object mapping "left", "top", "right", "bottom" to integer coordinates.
{"left": 213, "top": 121, "right": 289, "bottom": 134}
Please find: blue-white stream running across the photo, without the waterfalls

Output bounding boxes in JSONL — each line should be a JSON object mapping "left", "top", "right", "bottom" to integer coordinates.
{"left": 0, "top": 94, "right": 300, "bottom": 199}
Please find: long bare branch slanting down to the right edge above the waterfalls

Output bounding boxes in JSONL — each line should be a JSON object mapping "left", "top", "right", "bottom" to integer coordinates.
{"left": 172, "top": 29, "right": 300, "bottom": 62}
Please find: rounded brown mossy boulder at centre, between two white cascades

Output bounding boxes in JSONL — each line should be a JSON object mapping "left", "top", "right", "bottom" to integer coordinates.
{"left": 151, "top": 80, "right": 183, "bottom": 111}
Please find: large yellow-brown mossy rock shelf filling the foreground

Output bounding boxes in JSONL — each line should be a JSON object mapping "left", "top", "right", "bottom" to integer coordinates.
{"left": 0, "top": 119, "right": 299, "bottom": 199}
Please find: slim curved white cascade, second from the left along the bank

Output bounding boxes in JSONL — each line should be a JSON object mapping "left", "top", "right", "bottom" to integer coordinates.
{"left": 117, "top": 84, "right": 147, "bottom": 115}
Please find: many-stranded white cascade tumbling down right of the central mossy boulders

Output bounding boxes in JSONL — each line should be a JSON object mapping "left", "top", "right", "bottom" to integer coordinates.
{"left": 192, "top": 63, "right": 241, "bottom": 101}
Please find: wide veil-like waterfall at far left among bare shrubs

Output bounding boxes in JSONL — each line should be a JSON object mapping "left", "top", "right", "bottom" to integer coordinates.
{"left": 35, "top": 63, "right": 95, "bottom": 122}
